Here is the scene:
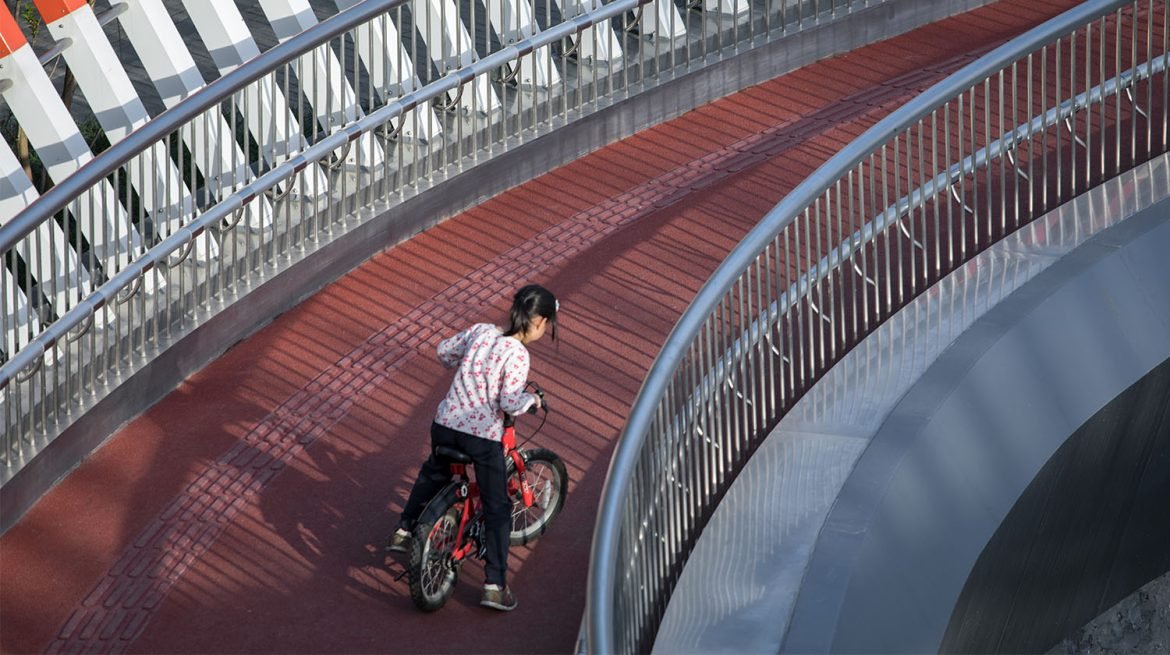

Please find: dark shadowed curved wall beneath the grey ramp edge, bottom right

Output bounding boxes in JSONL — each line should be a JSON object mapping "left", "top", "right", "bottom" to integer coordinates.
{"left": 942, "top": 359, "right": 1170, "bottom": 653}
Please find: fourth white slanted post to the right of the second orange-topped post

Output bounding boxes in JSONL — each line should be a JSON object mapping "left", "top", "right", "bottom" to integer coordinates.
{"left": 336, "top": 0, "right": 442, "bottom": 143}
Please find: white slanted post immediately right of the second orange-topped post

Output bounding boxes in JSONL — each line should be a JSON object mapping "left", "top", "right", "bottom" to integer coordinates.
{"left": 110, "top": 0, "right": 273, "bottom": 232}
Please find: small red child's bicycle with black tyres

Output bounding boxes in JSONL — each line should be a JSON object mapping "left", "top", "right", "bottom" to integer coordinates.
{"left": 406, "top": 382, "right": 569, "bottom": 612}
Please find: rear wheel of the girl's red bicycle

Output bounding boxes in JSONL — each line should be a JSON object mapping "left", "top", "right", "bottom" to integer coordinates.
{"left": 410, "top": 501, "right": 462, "bottom": 612}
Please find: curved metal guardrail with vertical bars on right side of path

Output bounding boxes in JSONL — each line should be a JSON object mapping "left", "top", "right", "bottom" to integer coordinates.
{"left": 583, "top": 0, "right": 1170, "bottom": 653}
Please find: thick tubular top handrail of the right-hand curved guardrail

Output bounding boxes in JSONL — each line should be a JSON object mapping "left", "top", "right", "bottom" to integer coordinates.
{"left": 584, "top": 0, "right": 1164, "bottom": 653}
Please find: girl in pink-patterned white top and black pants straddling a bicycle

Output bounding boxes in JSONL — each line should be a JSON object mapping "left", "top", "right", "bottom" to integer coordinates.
{"left": 387, "top": 284, "right": 558, "bottom": 612}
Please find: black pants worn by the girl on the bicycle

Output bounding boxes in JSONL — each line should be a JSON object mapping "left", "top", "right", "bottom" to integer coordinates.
{"left": 398, "top": 422, "right": 511, "bottom": 586}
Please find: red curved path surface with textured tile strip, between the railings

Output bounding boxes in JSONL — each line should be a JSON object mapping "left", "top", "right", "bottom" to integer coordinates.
{"left": 0, "top": 0, "right": 1076, "bottom": 654}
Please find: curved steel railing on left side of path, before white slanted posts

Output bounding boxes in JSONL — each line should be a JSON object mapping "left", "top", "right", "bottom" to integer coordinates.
{"left": 0, "top": 0, "right": 886, "bottom": 481}
